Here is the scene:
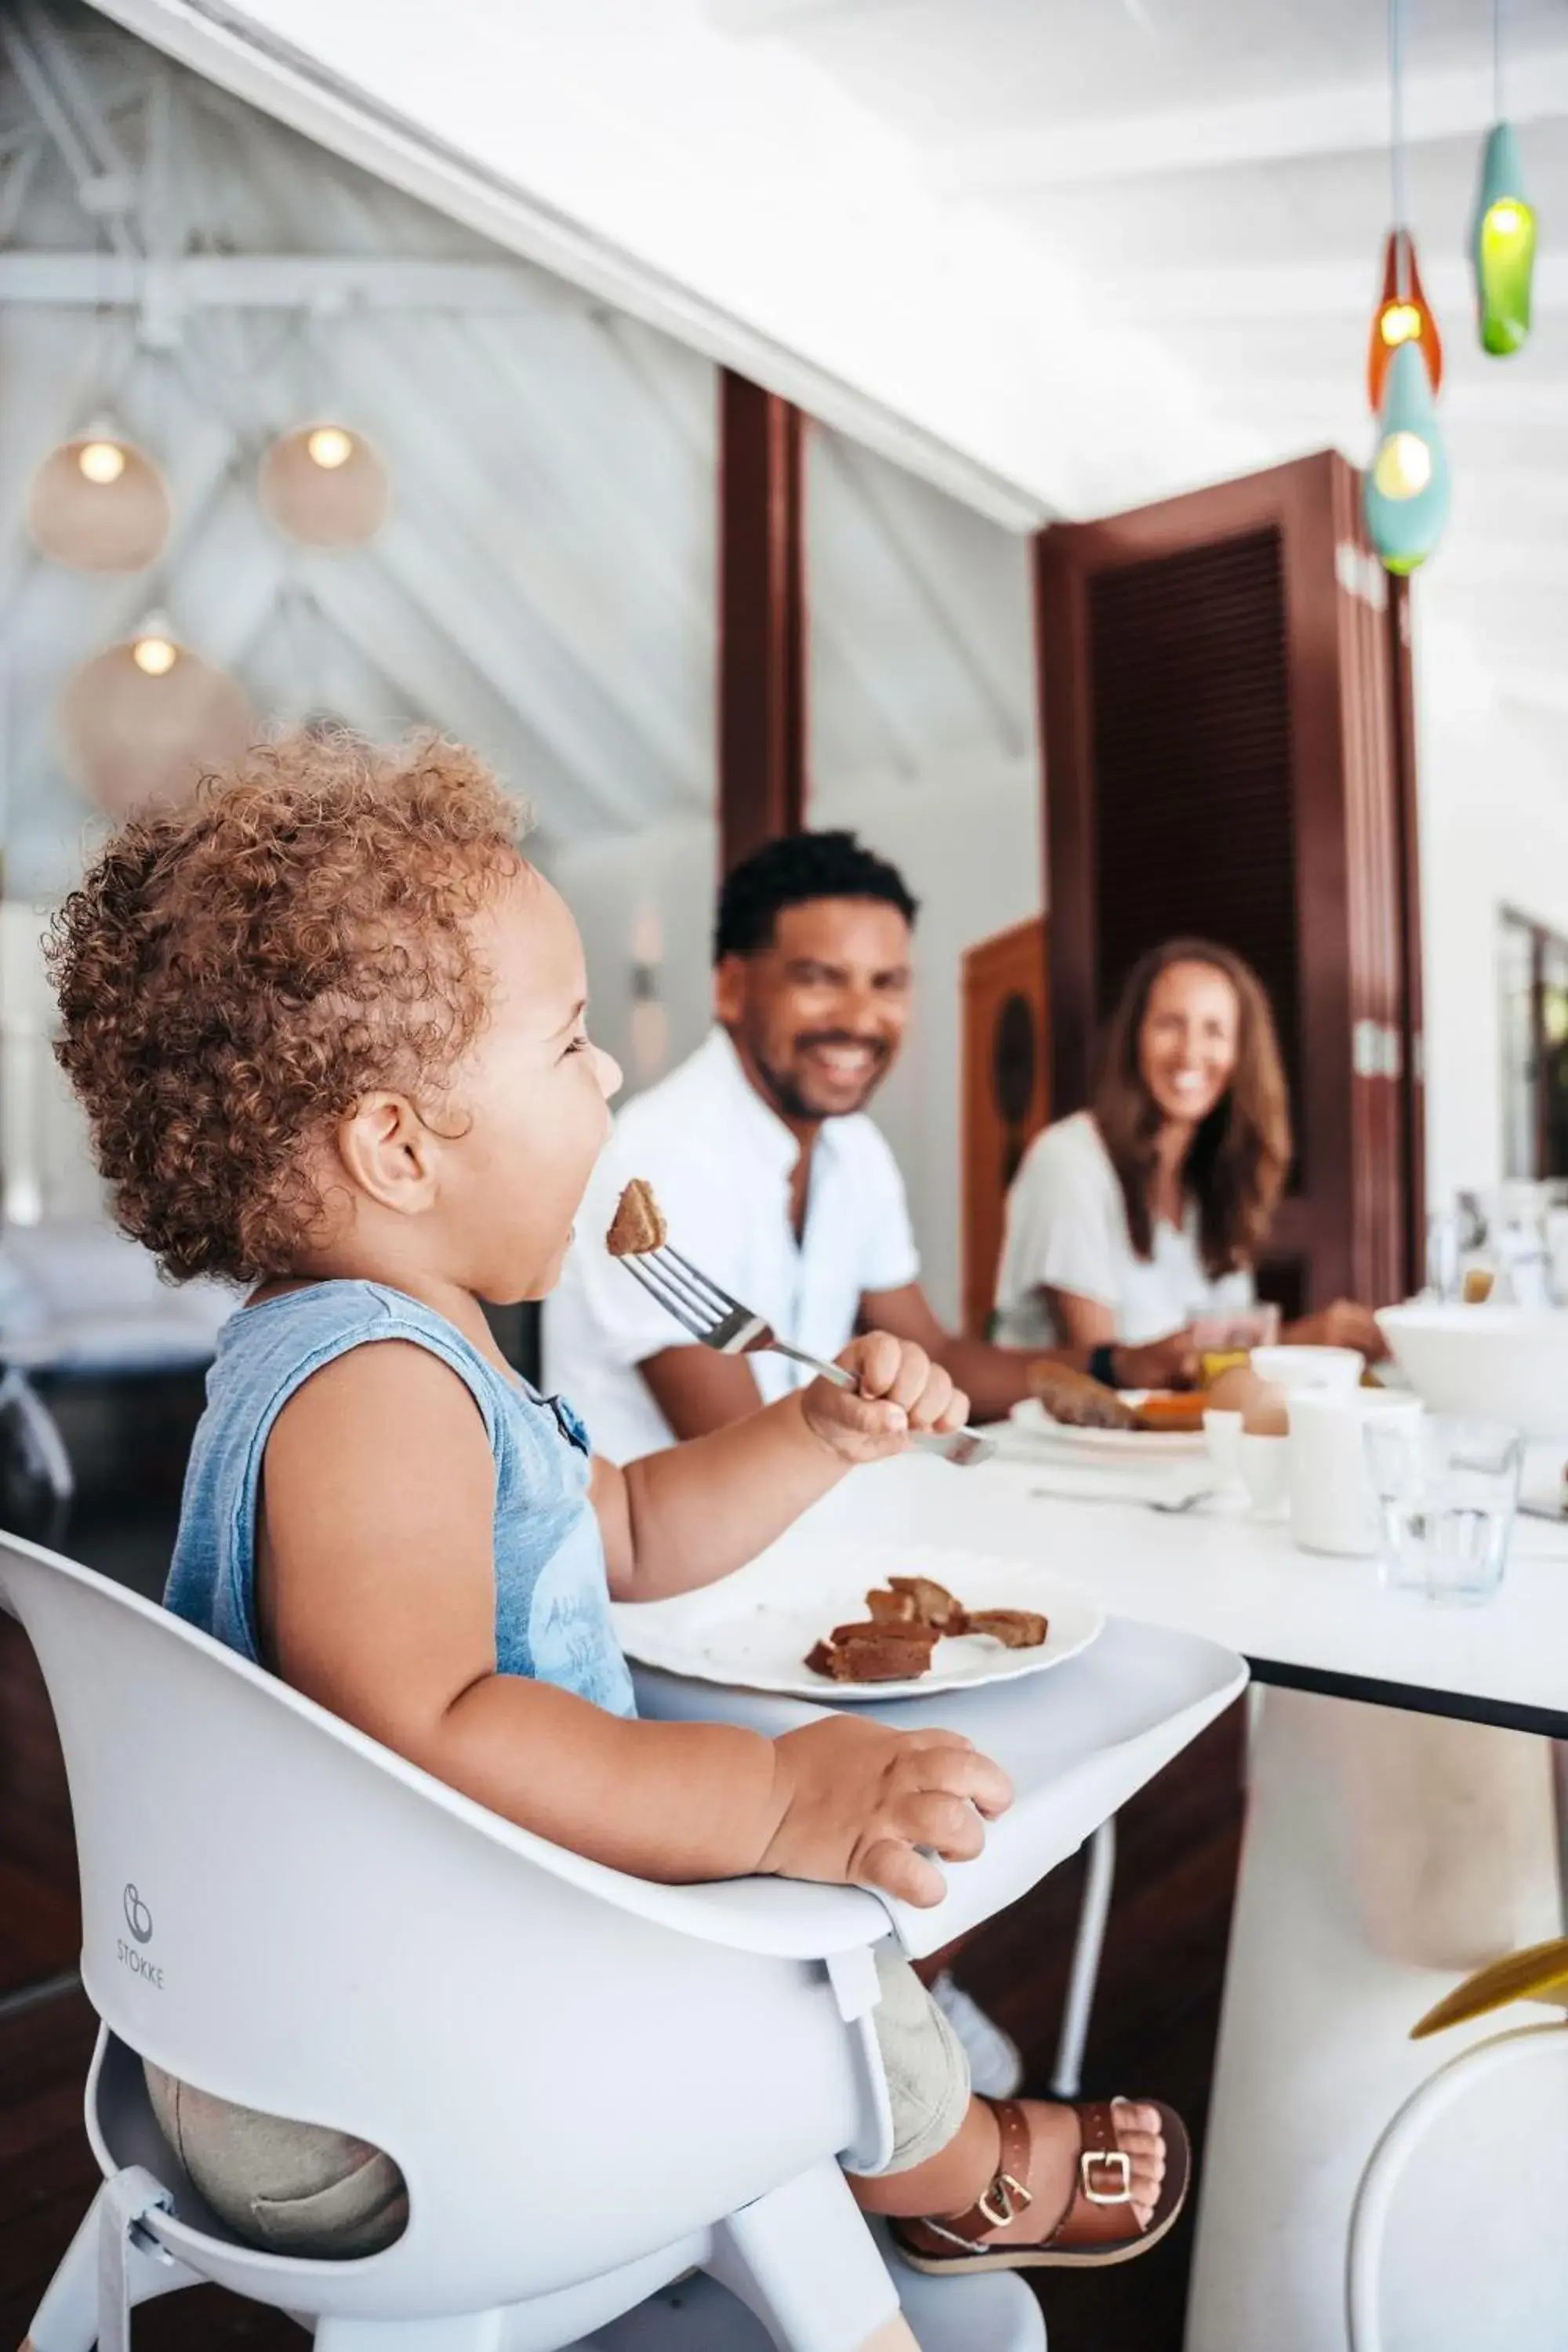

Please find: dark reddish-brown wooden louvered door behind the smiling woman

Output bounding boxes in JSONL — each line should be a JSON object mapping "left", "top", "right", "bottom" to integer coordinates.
{"left": 1036, "top": 454, "right": 1420, "bottom": 1310}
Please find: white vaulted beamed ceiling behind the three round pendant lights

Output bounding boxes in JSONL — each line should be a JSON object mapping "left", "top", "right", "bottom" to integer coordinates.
{"left": 0, "top": 0, "right": 1032, "bottom": 896}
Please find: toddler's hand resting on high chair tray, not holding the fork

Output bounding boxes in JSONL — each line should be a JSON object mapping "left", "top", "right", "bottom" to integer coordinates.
{"left": 762, "top": 1715, "right": 1013, "bottom": 1907}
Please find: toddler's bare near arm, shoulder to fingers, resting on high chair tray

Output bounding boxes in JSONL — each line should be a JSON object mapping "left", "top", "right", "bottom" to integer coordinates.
{"left": 256, "top": 1341, "right": 1011, "bottom": 1903}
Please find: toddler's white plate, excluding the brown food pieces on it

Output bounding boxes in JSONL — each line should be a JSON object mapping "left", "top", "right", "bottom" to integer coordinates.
{"left": 614, "top": 1543, "right": 1105, "bottom": 1705}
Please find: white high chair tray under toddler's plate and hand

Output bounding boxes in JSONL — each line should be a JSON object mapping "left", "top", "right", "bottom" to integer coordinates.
{"left": 633, "top": 1616, "right": 1246, "bottom": 1959}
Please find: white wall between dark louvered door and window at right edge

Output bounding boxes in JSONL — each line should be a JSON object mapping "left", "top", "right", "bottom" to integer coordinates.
{"left": 1417, "top": 687, "right": 1568, "bottom": 1202}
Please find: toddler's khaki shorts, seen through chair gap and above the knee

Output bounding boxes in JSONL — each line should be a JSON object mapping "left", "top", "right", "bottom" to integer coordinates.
{"left": 146, "top": 1955, "right": 968, "bottom": 2263}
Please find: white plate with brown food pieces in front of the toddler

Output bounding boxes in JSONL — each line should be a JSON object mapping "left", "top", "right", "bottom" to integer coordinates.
{"left": 616, "top": 1543, "right": 1105, "bottom": 1703}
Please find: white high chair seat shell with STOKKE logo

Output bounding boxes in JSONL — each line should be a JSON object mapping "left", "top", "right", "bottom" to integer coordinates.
{"left": 0, "top": 1536, "right": 886, "bottom": 2314}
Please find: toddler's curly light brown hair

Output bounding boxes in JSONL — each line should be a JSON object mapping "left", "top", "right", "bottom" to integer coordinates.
{"left": 49, "top": 731, "right": 524, "bottom": 1282}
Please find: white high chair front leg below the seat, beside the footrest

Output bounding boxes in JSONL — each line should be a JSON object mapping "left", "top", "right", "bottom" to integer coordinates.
{"left": 703, "top": 2164, "right": 914, "bottom": 2352}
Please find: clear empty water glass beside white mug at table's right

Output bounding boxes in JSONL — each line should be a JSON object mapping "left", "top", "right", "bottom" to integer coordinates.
{"left": 1363, "top": 1414, "right": 1523, "bottom": 1609}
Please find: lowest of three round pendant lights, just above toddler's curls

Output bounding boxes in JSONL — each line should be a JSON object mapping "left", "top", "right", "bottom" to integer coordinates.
{"left": 59, "top": 614, "right": 256, "bottom": 816}
